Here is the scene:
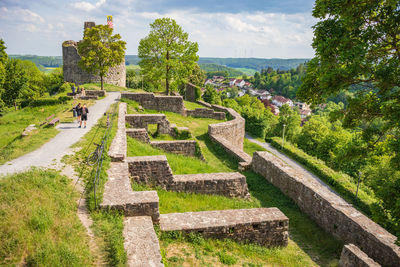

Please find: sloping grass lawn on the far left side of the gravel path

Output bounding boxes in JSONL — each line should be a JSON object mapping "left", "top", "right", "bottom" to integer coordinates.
{"left": 0, "top": 95, "right": 94, "bottom": 165}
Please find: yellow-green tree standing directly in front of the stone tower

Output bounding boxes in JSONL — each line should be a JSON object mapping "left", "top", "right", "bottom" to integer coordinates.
{"left": 78, "top": 25, "right": 126, "bottom": 90}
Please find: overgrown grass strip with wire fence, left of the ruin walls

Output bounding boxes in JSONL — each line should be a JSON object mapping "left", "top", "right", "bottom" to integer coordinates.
{"left": 64, "top": 102, "right": 126, "bottom": 266}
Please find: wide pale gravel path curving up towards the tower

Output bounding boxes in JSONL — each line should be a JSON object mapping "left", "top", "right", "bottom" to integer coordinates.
{"left": 0, "top": 92, "right": 120, "bottom": 175}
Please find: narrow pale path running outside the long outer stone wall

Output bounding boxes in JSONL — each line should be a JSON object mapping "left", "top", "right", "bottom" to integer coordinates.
{"left": 246, "top": 133, "right": 340, "bottom": 196}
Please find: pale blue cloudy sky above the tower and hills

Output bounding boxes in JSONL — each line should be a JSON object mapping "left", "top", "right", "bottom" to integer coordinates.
{"left": 0, "top": 0, "right": 317, "bottom": 58}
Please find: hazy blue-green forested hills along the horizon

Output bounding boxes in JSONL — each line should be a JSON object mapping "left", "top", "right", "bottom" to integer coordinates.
{"left": 9, "top": 55, "right": 309, "bottom": 75}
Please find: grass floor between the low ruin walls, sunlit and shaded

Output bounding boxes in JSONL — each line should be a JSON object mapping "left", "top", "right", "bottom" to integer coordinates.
{"left": 124, "top": 101, "right": 343, "bottom": 266}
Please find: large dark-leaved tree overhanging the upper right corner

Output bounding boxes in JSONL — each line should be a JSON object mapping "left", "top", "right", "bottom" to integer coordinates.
{"left": 298, "top": 0, "right": 400, "bottom": 163}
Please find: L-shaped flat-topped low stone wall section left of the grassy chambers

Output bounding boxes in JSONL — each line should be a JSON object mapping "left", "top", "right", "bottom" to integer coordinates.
{"left": 100, "top": 162, "right": 160, "bottom": 222}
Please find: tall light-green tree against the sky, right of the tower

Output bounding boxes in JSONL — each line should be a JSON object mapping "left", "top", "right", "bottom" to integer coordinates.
{"left": 138, "top": 18, "right": 199, "bottom": 95}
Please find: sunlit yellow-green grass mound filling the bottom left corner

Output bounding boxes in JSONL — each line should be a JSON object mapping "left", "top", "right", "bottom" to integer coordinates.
{"left": 0, "top": 169, "right": 93, "bottom": 266}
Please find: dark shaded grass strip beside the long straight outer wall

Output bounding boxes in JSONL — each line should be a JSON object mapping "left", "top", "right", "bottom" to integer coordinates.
{"left": 243, "top": 171, "right": 343, "bottom": 266}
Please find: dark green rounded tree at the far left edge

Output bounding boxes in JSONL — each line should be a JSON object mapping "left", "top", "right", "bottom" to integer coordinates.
{"left": 2, "top": 59, "right": 28, "bottom": 108}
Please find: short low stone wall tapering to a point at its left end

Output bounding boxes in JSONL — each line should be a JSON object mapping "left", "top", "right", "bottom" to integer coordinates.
{"left": 150, "top": 140, "right": 196, "bottom": 157}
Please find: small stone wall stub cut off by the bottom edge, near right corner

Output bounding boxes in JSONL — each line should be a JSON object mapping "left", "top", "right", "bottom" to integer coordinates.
{"left": 339, "top": 244, "right": 381, "bottom": 267}
